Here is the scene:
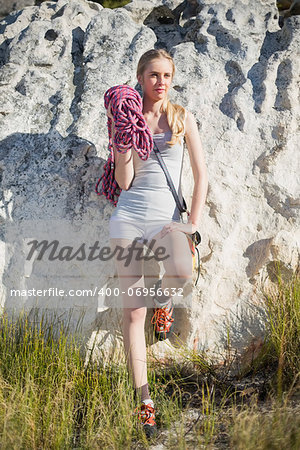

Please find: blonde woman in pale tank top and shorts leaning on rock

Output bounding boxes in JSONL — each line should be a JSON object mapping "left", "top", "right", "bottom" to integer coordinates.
{"left": 107, "top": 49, "right": 207, "bottom": 436}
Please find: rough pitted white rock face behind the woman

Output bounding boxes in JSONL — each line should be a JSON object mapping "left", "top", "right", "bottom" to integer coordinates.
{"left": 0, "top": 0, "right": 300, "bottom": 362}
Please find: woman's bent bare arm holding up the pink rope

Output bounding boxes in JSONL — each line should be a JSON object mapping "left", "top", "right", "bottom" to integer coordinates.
{"left": 107, "top": 103, "right": 134, "bottom": 191}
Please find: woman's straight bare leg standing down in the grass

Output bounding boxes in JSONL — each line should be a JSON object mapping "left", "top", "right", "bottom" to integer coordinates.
{"left": 110, "top": 238, "right": 149, "bottom": 400}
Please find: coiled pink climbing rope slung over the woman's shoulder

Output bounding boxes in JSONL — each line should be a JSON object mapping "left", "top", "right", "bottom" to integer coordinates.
{"left": 95, "top": 84, "right": 153, "bottom": 206}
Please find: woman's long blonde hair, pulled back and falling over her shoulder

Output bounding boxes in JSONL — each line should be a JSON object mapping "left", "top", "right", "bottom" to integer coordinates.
{"left": 136, "top": 48, "right": 186, "bottom": 145}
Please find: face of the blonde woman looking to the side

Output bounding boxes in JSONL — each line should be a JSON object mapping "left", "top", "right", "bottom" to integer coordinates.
{"left": 138, "top": 58, "right": 172, "bottom": 100}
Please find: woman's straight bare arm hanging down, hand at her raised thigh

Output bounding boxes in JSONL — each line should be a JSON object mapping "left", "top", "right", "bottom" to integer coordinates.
{"left": 185, "top": 111, "right": 208, "bottom": 230}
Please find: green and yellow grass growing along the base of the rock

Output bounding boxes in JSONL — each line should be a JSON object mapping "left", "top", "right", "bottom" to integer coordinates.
{"left": 0, "top": 270, "right": 300, "bottom": 450}
